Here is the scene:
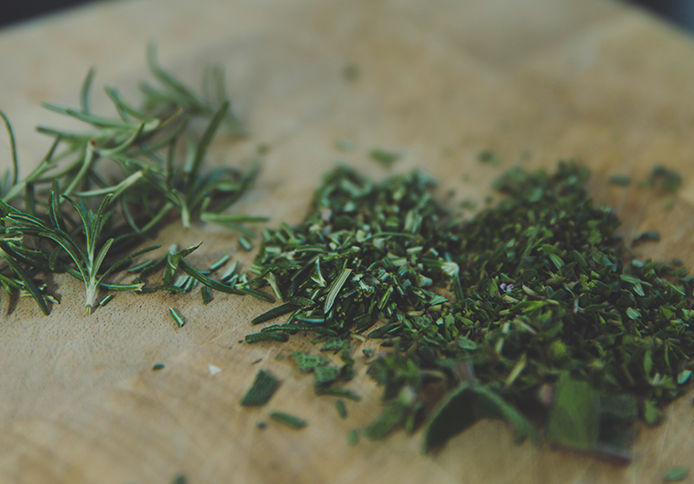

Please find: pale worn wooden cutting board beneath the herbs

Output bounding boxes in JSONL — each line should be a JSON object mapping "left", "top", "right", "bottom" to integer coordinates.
{"left": 0, "top": 0, "right": 694, "bottom": 484}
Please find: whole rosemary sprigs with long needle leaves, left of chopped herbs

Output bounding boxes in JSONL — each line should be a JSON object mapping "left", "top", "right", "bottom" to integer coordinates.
{"left": 0, "top": 48, "right": 267, "bottom": 314}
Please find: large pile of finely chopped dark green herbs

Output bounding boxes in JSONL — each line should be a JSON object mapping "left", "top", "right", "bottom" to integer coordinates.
{"left": 248, "top": 163, "right": 694, "bottom": 457}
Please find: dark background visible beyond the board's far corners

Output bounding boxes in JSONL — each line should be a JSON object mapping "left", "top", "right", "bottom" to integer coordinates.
{"left": 0, "top": 0, "right": 694, "bottom": 32}
